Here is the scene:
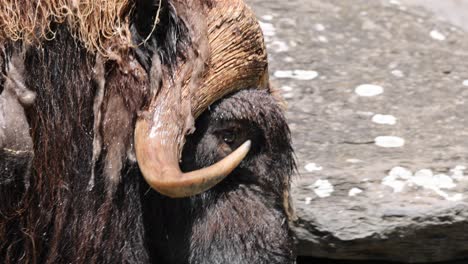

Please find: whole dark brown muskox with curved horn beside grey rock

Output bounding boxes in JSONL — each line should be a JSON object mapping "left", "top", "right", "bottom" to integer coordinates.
{"left": 0, "top": 0, "right": 294, "bottom": 263}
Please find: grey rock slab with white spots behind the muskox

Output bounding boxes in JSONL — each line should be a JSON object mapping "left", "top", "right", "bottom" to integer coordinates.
{"left": 248, "top": 0, "right": 468, "bottom": 263}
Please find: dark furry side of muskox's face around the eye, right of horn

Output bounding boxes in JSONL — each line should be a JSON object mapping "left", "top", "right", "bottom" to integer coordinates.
{"left": 145, "top": 90, "right": 295, "bottom": 264}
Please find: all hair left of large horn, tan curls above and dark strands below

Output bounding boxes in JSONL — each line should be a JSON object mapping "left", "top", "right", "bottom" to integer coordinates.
{"left": 0, "top": 0, "right": 209, "bottom": 263}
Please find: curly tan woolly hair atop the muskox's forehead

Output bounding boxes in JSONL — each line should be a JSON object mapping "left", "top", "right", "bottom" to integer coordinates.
{"left": 0, "top": 0, "right": 134, "bottom": 55}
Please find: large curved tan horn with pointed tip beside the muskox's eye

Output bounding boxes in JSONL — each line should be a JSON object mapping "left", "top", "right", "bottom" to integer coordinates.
{"left": 135, "top": 0, "right": 267, "bottom": 197}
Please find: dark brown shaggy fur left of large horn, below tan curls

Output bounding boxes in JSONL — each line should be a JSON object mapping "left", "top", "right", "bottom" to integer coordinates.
{"left": 0, "top": 1, "right": 186, "bottom": 263}
